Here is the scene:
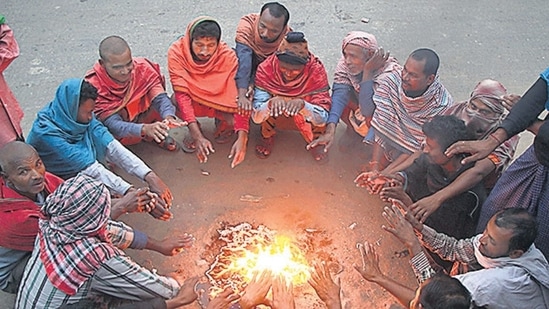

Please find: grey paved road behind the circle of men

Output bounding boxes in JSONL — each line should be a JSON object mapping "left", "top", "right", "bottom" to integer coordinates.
{"left": 0, "top": 0, "right": 549, "bottom": 308}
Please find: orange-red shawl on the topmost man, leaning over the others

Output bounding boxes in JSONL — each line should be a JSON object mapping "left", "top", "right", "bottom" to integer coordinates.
{"left": 235, "top": 14, "right": 290, "bottom": 62}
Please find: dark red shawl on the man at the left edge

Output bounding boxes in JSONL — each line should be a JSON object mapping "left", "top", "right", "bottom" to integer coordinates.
{"left": 0, "top": 172, "right": 63, "bottom": 251}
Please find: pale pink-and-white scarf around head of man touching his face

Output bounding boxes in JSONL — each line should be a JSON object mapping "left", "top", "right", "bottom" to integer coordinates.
{"left": 334, "top": 31, "right": 402, "bottom": 93}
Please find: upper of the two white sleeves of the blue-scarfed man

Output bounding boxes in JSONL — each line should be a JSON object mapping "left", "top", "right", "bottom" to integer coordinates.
{"left": 106, "top": 140, "right": 152, "bottom": 180}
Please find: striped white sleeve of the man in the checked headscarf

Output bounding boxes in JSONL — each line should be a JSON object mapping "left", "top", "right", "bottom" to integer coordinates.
{"left": 91, "top": 255, "right": 180, "bottom": 301}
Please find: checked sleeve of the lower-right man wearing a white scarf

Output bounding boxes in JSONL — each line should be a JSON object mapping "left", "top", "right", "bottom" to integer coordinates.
{"left": 417, "top": 225, "right": 480, "bottom": 264}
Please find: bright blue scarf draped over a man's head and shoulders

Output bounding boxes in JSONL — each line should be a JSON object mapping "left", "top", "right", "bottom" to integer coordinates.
{"left": 27, "top": 79, "right": 114, "bottom": 177}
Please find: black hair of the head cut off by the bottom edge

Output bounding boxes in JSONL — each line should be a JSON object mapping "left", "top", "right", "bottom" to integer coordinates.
{"left": 419, "top": 273, "right": 472, "bottom": 309}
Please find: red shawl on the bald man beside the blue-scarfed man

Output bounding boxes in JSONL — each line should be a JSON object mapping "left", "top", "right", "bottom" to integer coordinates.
{"left": 85, "top": 57, "right": 165, "bottom": 121}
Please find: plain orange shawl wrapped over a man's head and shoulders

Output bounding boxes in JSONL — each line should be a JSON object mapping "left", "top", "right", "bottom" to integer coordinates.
{"left": 168, "top": 16, "right": 238, "bottom": 113}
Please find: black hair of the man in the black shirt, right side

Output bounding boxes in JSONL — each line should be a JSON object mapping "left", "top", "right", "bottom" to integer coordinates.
{"left": 423, "top": 115, "right": 472, "bottom": 151}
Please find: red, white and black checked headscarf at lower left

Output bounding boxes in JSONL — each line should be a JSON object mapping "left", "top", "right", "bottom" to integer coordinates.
{"left": 38, "top": 174, "right": 123, "bottom": 295}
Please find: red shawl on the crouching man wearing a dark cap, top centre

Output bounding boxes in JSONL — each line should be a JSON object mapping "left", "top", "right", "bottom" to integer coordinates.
{"left": 255, "top": 54, "right": 331, "bottom": 110}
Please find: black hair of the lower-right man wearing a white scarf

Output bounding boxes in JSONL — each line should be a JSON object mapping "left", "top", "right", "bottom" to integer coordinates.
{"left": 494, "top": 208, "right": 538, "bottom": 252}
